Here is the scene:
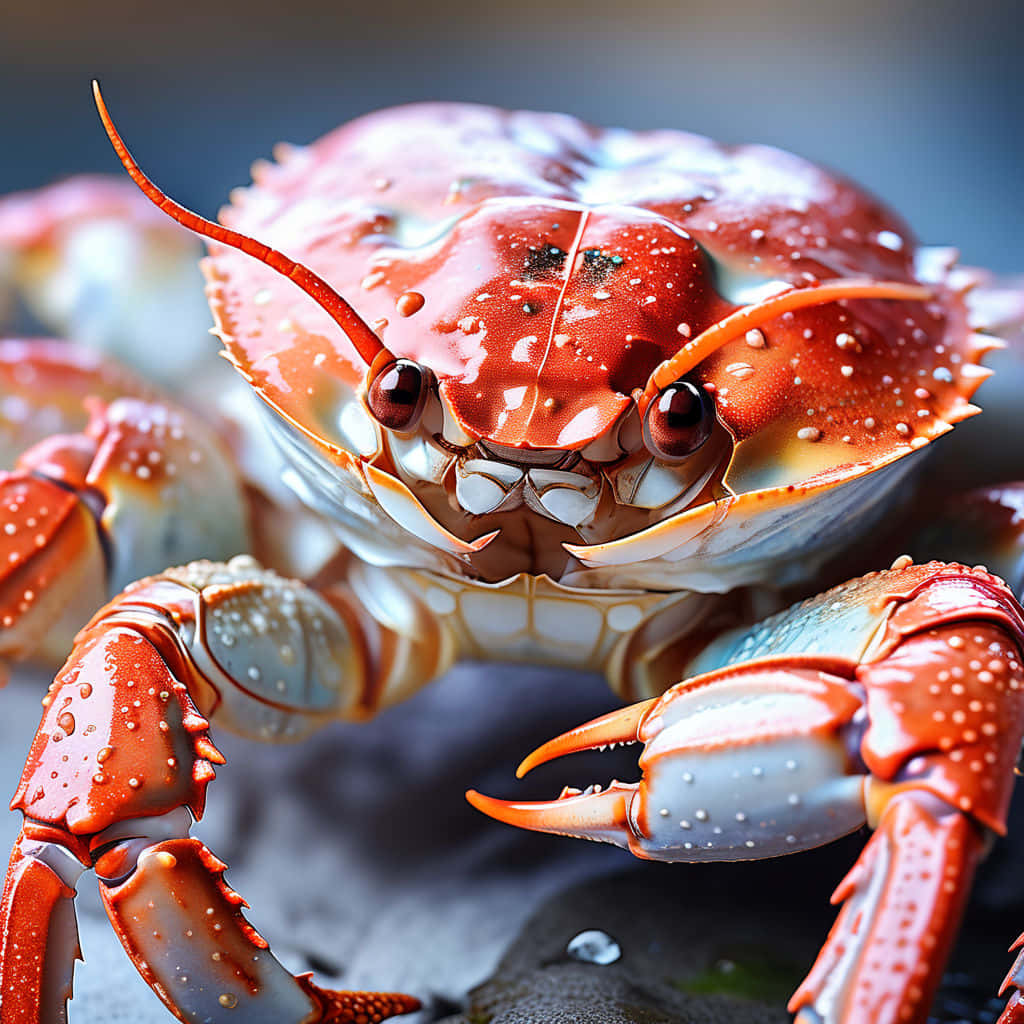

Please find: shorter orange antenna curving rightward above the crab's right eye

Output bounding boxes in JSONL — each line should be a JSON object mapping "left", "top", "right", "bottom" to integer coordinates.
{"left": 643, "top": 278, "right": 934, "bottom": 401}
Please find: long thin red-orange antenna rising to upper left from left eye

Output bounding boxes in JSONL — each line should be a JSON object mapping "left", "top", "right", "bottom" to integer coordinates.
{"left": 92, "top": 80, "right": 393, "bottom": 367}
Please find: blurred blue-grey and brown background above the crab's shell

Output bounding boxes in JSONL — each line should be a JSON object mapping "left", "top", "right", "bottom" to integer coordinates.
{"left": 0, "top": 0, "right": 1024, "bottom": 270}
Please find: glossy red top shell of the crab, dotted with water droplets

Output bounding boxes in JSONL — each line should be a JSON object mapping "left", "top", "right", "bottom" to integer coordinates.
{"left": 208, "top": 104, "right": 977, "bottom": 460}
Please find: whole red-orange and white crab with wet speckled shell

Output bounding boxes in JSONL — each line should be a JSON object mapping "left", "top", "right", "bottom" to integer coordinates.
{"left": 0, "top": 88, "right": 1024, "bottom": 1024}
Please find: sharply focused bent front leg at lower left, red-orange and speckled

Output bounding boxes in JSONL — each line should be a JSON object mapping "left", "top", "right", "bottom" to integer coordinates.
{"left": 0, "top": 558, "right": 419, "bottom": 1024}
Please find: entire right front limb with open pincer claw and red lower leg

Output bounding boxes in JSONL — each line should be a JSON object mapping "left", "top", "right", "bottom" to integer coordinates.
{"left": 469, "top": 563, "right": 1024, "bottom": 1024}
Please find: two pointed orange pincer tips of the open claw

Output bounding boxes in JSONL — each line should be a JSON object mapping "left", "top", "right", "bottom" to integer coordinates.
{"left": 466, "top": 697, "right": 658, "bottom": 847}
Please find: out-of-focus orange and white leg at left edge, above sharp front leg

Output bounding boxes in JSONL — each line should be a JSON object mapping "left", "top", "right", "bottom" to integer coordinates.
{"left": 0, "top": 342, "right": 248, "bottom": 660}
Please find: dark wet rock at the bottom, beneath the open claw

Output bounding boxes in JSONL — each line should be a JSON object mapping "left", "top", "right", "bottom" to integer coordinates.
{"left": 434, "top": 837, "right": 1015, "bottom": 1024}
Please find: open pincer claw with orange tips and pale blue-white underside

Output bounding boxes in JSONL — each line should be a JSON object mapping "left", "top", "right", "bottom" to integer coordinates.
{"left": 467, "top": 660, "right": 865, "bottom": 860}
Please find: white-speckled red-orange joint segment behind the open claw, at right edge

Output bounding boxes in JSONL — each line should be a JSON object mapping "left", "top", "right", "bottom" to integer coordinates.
{"left": 857, "top": 563, "right": 1024, "bottom": 834}
